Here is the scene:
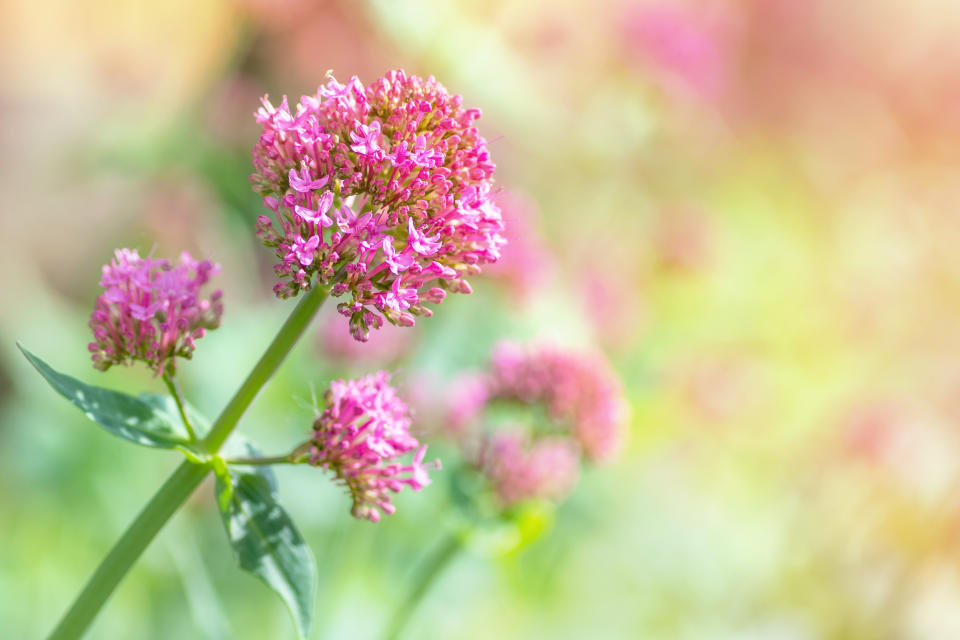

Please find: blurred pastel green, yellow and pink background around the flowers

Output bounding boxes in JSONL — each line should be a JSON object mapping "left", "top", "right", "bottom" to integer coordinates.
{"left": 0, "top": 0, "right": 960, "bottom": 640}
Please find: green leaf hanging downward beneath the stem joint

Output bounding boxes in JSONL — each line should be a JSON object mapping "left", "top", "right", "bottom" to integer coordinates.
{"left": 214, "top": 465, "right": 317, "bottom": 638}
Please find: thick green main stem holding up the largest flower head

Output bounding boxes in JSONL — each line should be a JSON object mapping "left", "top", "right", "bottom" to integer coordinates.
{"left": 49, "top": 287, "right": 329, "bottom": 640}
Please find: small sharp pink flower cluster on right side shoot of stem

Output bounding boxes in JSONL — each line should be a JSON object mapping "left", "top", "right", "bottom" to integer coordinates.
{"left": 310, "top": 371, "right": 440, "bottom": 522}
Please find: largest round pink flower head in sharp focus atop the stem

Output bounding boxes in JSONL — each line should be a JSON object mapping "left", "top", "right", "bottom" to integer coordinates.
{"left": 250, "top": 71, "right": 505, "bottom": 341}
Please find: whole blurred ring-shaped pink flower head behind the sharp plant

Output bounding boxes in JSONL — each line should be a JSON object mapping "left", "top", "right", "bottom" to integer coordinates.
{"left": 448, "top": 344, "right": 626, "bottom": 505}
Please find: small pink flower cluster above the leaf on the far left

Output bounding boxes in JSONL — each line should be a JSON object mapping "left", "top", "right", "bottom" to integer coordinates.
{"left": 88, "top": 249, "right": 223, "bottom": 375}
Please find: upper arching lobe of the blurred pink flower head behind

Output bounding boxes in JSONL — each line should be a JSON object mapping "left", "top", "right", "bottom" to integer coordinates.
{"left": 488, "top": 344, "right": 626, "bottom": 461}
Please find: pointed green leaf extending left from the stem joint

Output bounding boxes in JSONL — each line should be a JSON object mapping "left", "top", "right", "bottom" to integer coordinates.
{"left": 17, "top": 344, "right": 189, "bottom": 449}
